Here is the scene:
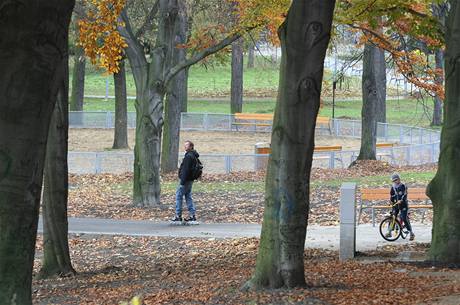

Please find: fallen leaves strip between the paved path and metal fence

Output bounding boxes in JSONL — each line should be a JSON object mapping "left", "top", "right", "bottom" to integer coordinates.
{"left": 68, "top": 161, "right": 434, "bottom": 225}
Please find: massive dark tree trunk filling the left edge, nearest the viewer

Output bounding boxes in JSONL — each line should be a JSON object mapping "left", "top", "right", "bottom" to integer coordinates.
{"left": 0, "top": 0, "right": 74, "bottom": 305}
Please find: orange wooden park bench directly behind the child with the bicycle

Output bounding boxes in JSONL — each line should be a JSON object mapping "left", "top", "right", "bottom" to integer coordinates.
{"left": 358, "top": 188, "right": 433, "bottom": 226}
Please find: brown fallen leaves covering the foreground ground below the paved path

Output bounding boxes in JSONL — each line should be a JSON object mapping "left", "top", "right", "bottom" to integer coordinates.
{"left": 33, "top": 235, "right": 460, "bottom": 305}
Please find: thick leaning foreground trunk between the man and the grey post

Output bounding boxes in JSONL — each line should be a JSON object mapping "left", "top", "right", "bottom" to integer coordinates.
{"left": 246, "top": 0, "right": 335, "bottom": 288}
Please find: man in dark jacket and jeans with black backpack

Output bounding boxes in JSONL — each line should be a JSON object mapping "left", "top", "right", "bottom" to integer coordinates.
{"left": 172, "top": 141, "right": 200, "bottom": 222}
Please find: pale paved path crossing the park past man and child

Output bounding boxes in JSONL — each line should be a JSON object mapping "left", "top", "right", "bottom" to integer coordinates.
{"left": 39, "top": 218, "right": 431, "bottom": 251}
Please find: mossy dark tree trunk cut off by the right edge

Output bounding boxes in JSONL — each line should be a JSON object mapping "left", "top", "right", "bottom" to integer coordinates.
{"left": 427, "top": 0, "right": 460, "bottom": 264}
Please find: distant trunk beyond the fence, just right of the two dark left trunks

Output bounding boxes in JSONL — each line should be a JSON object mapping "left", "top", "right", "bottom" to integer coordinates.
{"left": 70, "top": 46, "right": 86, "bottom": 111}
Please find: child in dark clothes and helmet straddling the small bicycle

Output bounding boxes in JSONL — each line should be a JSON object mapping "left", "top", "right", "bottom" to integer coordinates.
{"left": 387, "top": 173, "right": 415, "bottom": 240}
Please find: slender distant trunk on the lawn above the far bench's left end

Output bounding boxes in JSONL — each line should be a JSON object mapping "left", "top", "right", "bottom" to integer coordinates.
{"left": 230, "top": 38, "right": 243, "bottom": 113}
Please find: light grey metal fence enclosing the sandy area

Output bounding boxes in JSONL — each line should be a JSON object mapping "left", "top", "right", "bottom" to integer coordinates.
{"left": 69, "top": 112, "right": 440, "bottom": 174}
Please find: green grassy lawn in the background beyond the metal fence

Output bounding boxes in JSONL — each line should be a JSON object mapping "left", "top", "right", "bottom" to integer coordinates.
{"left": 76, "top": 59, "right": 438, "bottom": 127}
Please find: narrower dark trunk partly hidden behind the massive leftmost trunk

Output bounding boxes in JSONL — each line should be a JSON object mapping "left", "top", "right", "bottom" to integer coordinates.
{"left": 38, "top": 64, "right": 75, "bottom": 278}
